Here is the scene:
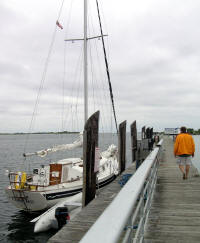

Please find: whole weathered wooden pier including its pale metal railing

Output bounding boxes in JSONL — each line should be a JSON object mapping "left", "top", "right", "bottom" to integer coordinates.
{"left": 48, "top": 136, "right": 200, "bottom": 243}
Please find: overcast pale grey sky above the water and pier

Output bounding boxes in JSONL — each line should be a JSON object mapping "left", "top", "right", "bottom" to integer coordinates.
{"left": 0, "top": 0, "right": 200, "bottom": 132}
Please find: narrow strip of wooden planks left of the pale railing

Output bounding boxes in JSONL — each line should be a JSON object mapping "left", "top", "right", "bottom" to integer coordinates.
{"left": 48, "top": 163, "right": 135, "bottom": 243}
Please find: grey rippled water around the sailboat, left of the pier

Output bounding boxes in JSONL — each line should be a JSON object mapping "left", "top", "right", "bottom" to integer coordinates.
{"left": 0, "top": 134, "right": 131, "bottom": 243}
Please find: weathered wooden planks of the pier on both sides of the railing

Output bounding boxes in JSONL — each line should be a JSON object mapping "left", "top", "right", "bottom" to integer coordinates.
{"left": 48, "top": 136, "right": 200, "bottom": 243}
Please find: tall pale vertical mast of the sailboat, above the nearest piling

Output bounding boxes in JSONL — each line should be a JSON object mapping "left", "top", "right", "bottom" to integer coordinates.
{"left": 84, "top": 0, "right": 88, "bottom": 123}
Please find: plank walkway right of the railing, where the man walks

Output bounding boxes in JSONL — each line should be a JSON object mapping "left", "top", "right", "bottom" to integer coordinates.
{"left": 144, "top": 137, "right": 200, "bottom": 243}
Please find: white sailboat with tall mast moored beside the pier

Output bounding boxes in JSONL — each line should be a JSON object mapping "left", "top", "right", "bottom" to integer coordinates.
{"left": 5, "top": 0, "right": 119, "bottom": 212}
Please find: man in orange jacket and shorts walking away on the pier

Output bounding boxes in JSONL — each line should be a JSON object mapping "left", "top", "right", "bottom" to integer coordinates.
{"left": 174, "top": 127, "right": 195, "bottom": 180}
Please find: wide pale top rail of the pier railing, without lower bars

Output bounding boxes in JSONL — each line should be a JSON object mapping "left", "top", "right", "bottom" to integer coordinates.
{"left": 80, "top": 140, "right": 163, "bottom": 243}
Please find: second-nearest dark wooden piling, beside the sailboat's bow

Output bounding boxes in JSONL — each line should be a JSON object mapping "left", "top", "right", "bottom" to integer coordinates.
{"left": 118, "top": 121, "right": 126, "bottom": 174}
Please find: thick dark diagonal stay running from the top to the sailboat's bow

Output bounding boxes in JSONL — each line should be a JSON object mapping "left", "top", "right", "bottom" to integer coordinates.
{"left": 96, "top": 0, "right": 118, "bottom": 133}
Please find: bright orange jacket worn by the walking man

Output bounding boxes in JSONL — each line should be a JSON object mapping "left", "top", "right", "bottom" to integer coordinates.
{"left": 174, "top": 133, "right": 195, "bottom": 155}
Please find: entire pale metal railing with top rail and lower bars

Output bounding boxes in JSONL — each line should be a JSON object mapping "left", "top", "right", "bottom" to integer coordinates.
{"left": 80, "top": 140, "right": 163, "bottom": 243}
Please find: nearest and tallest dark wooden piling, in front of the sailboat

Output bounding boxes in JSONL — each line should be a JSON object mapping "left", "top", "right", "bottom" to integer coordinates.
{"left": 82, "top": 111, "right": 99, "bottom": 207}
